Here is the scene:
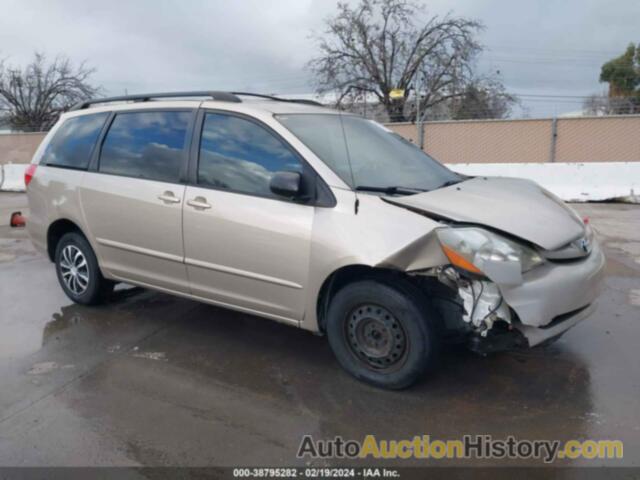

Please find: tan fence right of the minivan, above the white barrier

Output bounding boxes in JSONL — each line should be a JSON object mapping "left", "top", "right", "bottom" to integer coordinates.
{"left": 387, "top": 115, "right": 640, "bottom": 163}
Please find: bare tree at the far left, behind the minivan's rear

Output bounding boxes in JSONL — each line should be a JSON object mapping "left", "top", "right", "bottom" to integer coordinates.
{"left": 0, "top": 53, "right": 101, "bottom": 131}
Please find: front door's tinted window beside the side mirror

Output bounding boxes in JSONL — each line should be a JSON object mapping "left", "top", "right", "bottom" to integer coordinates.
{"left": 198, "top": 113, "right": 302, "bottom": 197}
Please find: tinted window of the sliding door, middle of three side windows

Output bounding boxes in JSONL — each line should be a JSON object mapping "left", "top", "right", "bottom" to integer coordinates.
{"left": 98, "top": 111, "right": 191, "bottom": 182}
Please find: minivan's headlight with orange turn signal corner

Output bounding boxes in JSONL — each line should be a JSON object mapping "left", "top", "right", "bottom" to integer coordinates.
{"left": 436, "top": 227, "right": 544, "bottom": 283}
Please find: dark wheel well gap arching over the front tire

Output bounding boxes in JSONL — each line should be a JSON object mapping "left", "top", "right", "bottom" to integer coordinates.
{"left": 316, "top": 265, "right": 424, "bottom": 332}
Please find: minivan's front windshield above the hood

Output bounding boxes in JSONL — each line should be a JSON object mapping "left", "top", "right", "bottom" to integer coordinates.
{"left": 276, "top": 114, "right": 462, "bottom": 194}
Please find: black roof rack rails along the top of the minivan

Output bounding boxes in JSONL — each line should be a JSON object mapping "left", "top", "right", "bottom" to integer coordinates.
{"left": 70, "top": 91, "right": 324, "bottom": 111}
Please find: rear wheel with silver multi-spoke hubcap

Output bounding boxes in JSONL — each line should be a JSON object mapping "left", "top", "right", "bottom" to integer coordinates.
{"left": 55, "top": 232, "right": 114, "bottom": 305}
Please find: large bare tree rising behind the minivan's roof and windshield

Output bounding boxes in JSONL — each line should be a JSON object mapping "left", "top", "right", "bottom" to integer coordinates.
{"left": 309, "top": 0, "right": 482, "bottom": 121}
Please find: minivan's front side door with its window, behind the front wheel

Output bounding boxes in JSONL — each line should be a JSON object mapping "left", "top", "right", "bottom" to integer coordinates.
{"left": 184, "top": 111, "right": 314, "bottom": 322}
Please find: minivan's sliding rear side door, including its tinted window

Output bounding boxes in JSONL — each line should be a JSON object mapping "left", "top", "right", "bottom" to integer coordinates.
{"left": 81, "top": 109, "right": 195, "bottom": 293}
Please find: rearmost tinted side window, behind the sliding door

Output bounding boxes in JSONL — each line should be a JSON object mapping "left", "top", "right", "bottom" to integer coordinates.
{"left": 41, "top": 113, "right": 109, "bottom": 169}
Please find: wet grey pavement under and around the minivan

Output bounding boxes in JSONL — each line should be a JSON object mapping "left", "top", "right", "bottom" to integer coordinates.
{"left": 0, "top": 194, "right": 640, "bottom": 466}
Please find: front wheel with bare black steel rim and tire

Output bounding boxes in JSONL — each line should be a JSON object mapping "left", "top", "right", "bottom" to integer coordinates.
{"left": 326, "top": 280, "right": 440, "bottom": 390}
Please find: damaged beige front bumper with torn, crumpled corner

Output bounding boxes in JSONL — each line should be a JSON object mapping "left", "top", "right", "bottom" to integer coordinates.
{"left": 440, "top": 242, "right": 605, "bottom": 353}
